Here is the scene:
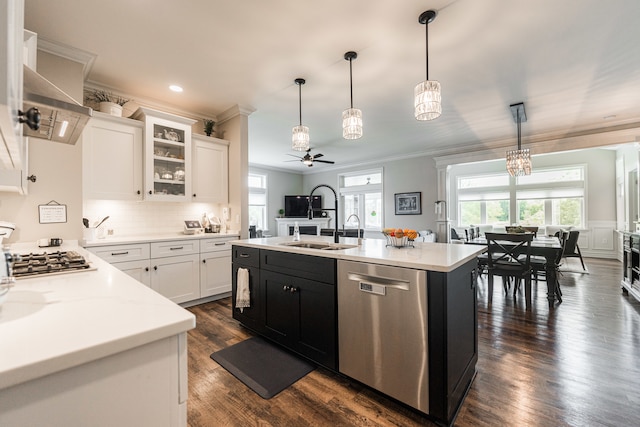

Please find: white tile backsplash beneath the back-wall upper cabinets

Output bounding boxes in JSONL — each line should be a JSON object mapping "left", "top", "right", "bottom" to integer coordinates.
{"left": 83, "top": 200, "right": 222, "bottom": 236}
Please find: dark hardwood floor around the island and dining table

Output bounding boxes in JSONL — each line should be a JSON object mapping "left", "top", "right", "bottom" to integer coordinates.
{"left": 188, "top": 258, "right": 640, "bottom": 427}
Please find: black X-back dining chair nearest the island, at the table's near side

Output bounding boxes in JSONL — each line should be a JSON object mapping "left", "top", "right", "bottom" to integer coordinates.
{"left": 485, "top": 233, "right": 533, "bottom": 305}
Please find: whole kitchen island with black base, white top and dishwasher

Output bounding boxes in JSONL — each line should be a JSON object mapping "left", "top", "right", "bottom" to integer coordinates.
{"left": 232, "top": 236, "right": 483, "bottom": 425}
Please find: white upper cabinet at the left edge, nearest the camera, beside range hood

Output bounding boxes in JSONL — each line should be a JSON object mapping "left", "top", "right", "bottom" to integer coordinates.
{"left": 0, "top": 0, "right": 26, "bottom": 170}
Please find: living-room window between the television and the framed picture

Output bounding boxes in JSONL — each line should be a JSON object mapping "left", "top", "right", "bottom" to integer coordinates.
{"left": 338, "top": 169, "right": 383, "bottom": 231}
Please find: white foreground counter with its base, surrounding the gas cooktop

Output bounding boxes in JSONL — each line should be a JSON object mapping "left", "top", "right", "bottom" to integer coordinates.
{"left": 0, "top": 242, "right": 195, "bottom": 426}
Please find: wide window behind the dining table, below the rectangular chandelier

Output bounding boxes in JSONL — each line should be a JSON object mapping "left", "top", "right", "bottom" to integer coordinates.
{"left": 456, "top": 165, "right": 586, "bottom": 227}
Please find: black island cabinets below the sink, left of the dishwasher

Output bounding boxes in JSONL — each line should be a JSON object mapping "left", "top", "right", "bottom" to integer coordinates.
{"left": 232, "top": 246, "right": 338, "bottom": 370}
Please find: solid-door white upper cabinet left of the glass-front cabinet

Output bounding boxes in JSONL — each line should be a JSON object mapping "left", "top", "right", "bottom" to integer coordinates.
{"left": 82, "top": 112, "right": 143, "bottom": 200}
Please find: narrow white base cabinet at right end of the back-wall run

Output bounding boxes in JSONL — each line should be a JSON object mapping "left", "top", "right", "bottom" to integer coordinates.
{"left": 200, "top": 239, "right": 234, "bottom": 298}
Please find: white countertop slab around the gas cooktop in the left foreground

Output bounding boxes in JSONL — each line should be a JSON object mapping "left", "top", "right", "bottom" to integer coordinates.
{"left": 0, "top": 242, "right": 195, "bottom": 389}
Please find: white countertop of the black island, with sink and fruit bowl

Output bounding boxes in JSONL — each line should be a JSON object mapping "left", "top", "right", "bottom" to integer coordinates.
{"left": 231, "top": 235, "right": 485, "bottom": 272}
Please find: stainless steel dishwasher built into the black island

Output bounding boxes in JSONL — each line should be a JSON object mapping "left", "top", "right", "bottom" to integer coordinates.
{"left": 338, "top": 260, "right": 429, "bottom": 413}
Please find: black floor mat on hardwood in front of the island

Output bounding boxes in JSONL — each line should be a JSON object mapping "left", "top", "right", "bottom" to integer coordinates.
{"left": 211, "top": 337, "right": 316, "bottom": 399}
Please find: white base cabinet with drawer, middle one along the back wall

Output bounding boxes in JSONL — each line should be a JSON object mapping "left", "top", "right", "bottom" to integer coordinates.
{"left": 151, "top": 239, "right": 200, "bottom": 303}
